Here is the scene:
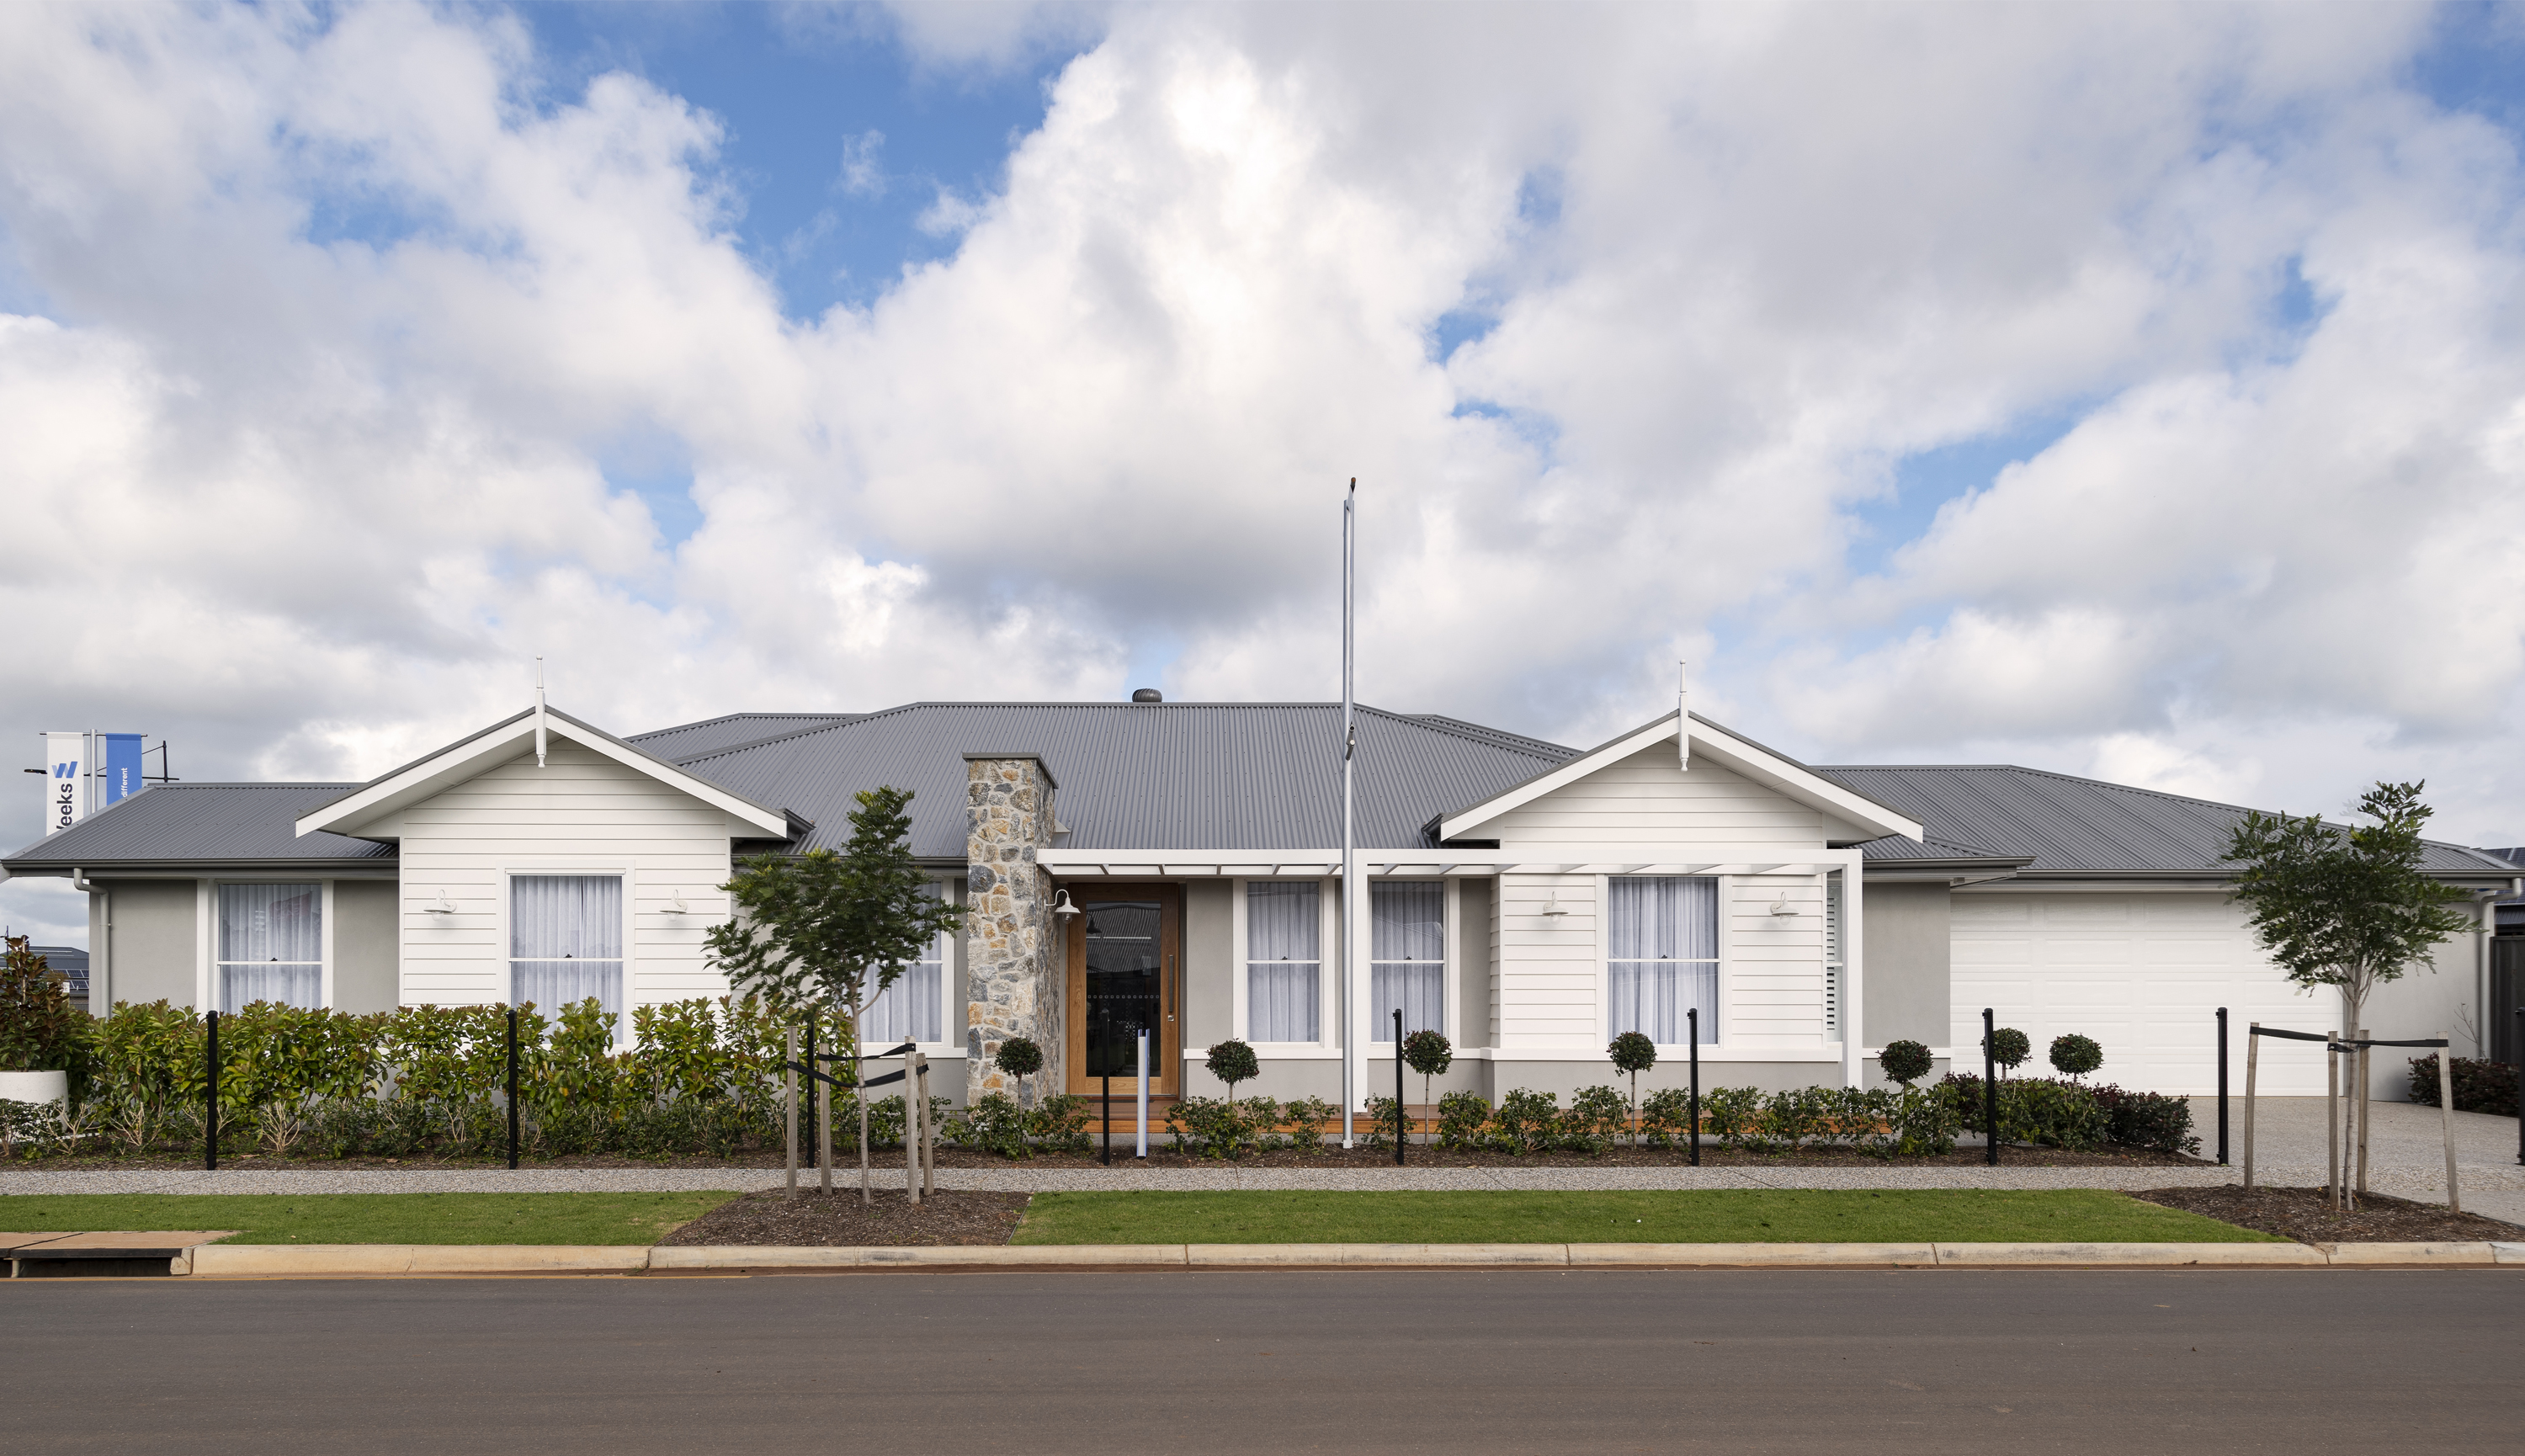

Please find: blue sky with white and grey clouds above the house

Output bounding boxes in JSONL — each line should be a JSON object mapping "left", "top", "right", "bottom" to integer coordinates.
{"left": 0, "top": 3, "right": 2525, "bottom": 943}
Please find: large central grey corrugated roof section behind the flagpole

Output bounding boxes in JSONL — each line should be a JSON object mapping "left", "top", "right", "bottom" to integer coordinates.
{"left": 677, "top": 702, "right": 1576, "bottom": 860}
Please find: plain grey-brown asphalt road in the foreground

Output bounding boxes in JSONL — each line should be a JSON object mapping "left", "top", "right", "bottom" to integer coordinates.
{"left": 0, "top": 1269, "right": 2525, "bottom": 1456}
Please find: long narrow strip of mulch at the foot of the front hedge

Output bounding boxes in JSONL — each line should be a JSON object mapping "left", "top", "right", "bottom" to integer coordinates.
{"left": 0, "top": 1135, "right": 2204, "bottom": 1176}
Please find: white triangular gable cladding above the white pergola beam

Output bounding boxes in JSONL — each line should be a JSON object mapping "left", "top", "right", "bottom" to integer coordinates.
{"left": 1480, "top": 736, "right": 1823, "bottom": 858}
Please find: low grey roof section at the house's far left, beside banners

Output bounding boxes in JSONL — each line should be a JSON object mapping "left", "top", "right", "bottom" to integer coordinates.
{"left": 0, "top": 784, "right": 394, "bottom": 875}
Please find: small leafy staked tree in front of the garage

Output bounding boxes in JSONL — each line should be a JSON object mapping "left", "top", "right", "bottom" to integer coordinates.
{"left": 2227, "top": 779, "right": 2472, "bottom": 1193}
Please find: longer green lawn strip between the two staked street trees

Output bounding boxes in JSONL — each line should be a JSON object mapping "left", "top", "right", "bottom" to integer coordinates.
{"left": 1015, "top": 1188, "right": 2285, "bottom": 1244}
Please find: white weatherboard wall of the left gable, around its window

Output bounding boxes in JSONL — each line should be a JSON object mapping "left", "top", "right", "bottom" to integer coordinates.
{"left": 381, "top": 734, "right": 750, "bottom": 1004}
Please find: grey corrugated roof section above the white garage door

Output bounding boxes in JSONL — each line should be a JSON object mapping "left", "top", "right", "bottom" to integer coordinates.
{"left": 1815, "top": 764, "right": 2517, "bottom": 878}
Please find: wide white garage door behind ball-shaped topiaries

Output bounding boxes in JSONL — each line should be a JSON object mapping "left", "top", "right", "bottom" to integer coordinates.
{"left": 1952, "top": 890, "right": 2341, "bottom": 1097}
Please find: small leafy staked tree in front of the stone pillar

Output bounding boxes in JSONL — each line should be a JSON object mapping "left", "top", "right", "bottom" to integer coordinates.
{"left": 707, "top": 787, "right": 965, "bottom": 1204}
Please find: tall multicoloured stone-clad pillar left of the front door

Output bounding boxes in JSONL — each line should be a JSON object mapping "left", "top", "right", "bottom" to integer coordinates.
{"left": 965, "top": 754, "right": 1068, "bottom": 1105}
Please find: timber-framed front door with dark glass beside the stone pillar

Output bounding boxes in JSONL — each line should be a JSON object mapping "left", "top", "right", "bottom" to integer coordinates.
{"left": 1068, "top": 885, "right": 1184, "bottom": 1097}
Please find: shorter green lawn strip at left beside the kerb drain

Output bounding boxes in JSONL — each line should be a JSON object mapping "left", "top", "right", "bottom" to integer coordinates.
{"left": 0, "top": 1193, "right": 735, "bottom": 1244}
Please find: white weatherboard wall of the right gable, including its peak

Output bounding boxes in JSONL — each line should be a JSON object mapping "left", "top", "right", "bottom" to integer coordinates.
{"left": 1482, "top": 739, "right": 1848, "bottom": 1049}
